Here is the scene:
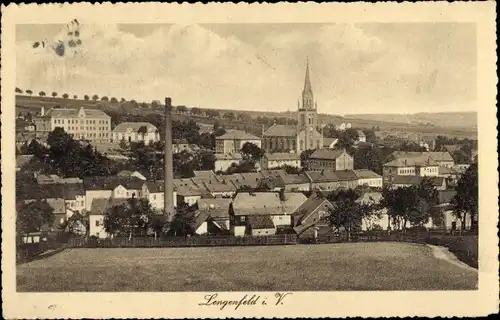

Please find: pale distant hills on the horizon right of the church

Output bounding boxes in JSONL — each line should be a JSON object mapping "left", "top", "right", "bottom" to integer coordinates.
{"left": 344, "top": 111, "right": 477, "bottom": 129}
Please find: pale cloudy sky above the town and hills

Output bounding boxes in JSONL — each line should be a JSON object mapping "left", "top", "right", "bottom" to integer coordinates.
{"left": 16, "top": 21, "right": 477, "bottom": 115}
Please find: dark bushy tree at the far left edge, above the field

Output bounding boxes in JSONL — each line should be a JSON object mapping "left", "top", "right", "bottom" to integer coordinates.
{"left": 16, "top": 201, "right": 54, "bottom": 234}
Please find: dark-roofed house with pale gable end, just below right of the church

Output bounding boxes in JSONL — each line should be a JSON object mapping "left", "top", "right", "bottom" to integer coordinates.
{"left": 307, "top": 149, "right": 354, "bottom": 171}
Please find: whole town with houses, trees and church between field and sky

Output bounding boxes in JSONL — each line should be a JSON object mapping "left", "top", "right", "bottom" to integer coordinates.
{"left": 16, "top": 64, "right": 478, "bottom": 251}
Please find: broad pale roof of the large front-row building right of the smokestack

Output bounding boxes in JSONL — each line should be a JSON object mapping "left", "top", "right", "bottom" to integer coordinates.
{"left": 233, "top": 192, "right": 307, "bottom": 215}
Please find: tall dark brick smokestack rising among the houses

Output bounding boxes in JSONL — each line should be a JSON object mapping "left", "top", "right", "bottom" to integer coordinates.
{"left": 163, "top": 97, "right": 174, "bottom": 221}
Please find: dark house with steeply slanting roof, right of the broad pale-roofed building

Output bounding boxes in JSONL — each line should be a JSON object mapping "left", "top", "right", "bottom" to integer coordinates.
{"left": 292, "top": 193, "right": 333, "bottom": 238}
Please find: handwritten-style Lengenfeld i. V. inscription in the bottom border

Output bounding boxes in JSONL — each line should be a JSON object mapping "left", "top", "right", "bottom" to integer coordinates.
{"left": 198, "top": 292, "right": 292, "bottom": 310}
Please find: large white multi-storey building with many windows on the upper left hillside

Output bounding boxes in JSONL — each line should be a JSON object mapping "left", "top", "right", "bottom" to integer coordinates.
{"left": 33, "top": 107, "right": 111, "bottom": 143}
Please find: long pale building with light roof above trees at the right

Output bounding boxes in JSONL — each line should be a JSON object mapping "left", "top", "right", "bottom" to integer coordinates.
{"left": 382, "top": 155, "right": 439, "bottom": 184}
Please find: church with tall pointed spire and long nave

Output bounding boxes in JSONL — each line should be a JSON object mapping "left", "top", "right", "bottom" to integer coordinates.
{"left": 262, "top": 62, "right": 323, "bottom": 154}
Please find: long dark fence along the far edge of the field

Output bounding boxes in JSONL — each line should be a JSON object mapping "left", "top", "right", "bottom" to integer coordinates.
{"left": 68, "top": 234, "right": 297, "bottom": 248}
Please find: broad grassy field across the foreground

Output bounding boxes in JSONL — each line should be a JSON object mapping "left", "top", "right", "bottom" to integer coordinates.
{"left": 17, "top": 243, "right": 477, "bottom": 292}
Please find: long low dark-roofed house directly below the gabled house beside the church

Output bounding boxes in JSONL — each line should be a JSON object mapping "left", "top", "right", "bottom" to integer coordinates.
{"left": 306, "top": 170, "right": 358, "bottom": 191}
